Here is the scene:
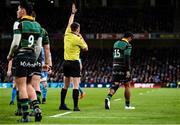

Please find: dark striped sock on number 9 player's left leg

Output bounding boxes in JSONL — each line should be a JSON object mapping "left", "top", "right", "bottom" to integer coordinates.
{"left": 20, "top": 98, "right": 29, "bottom": 119}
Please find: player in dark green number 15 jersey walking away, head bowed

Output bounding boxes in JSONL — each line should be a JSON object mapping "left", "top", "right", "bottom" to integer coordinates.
{"left": 105, "top": 32, "right": 135, "bottom": 109}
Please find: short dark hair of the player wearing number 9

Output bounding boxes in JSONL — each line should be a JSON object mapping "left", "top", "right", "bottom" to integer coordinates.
{"left": 19, "top": 0, "right": 34, "bottom": 15}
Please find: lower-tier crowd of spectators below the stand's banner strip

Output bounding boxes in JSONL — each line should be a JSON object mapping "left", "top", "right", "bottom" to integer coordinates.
{"left": 0, "top": 48, "right": 180, "bottom": 83}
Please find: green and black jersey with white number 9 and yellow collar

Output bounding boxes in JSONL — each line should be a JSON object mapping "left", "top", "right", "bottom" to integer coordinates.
{"left": 13, "top": 16, "right": 42, "bottom": 49}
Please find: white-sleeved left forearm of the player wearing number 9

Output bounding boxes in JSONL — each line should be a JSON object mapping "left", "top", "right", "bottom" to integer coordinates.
{"left": 8, "top": 34, "right": 21, "bottom": 57}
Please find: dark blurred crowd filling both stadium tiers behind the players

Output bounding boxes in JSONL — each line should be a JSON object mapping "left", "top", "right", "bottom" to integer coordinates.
{"left": 0, "top": 0, "right": 180, "bottom": 86}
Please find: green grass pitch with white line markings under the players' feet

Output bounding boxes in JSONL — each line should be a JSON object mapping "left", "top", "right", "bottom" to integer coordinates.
{"left": 0, "top": 88, "right": 180, "bottom": 124}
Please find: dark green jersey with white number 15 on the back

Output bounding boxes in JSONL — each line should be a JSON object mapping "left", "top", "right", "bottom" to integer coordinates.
{"left": 113, "top": 38, "right": 132, "bottom": 71}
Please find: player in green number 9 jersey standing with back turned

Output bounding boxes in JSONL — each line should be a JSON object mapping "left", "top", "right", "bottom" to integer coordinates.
{"left": 7, "top": 0, "right": 42, "bottom": 122}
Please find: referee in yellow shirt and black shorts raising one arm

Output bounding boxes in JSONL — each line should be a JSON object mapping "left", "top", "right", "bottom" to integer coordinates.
{"left": 59, "top": 4, "right": 88, "bottom": 111}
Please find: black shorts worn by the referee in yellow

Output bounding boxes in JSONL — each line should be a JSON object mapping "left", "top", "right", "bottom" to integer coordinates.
{"left": 63, "top": 60, "right": 81, "bottom": 77}
